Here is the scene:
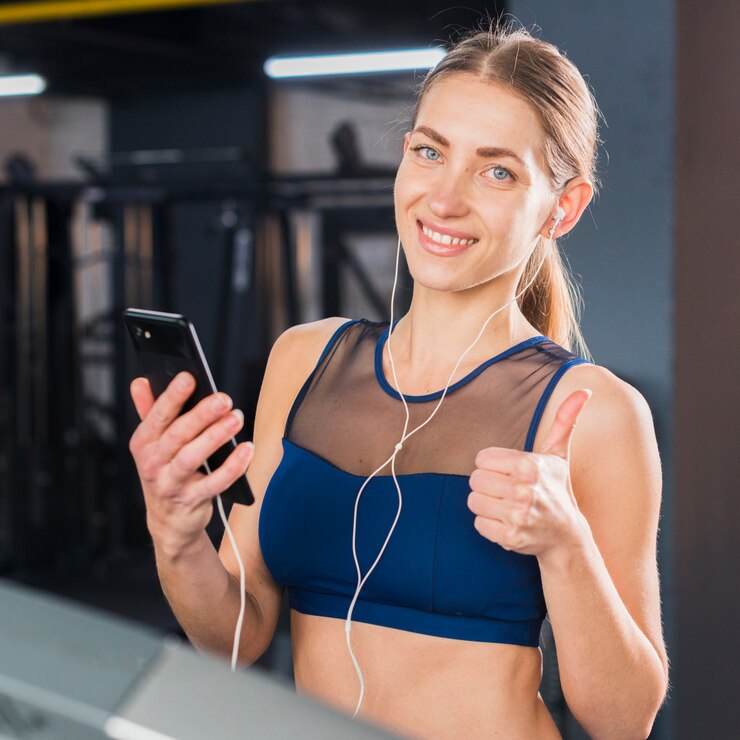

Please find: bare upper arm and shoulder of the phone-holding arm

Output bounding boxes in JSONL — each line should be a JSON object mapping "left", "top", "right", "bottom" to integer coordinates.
{"left": 219, "top": 318, "right": 346, "bottom": 648}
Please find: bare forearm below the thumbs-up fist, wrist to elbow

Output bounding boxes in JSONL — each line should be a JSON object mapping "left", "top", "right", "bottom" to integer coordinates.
{"left": 539, "top": 518, "right": 666, "bottom": 738}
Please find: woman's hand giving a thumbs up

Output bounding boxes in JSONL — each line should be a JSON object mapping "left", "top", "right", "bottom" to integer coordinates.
{"left": 468, "top": 389, "right": 591, "bottom": 556}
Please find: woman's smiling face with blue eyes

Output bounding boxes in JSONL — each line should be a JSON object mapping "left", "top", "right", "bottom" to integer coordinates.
{"left": 395, "top": 73, "right": 557, "bottom": 291}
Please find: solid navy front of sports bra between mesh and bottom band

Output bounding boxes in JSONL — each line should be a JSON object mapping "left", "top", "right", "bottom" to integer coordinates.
{"left": 260, "top": 440, "right": 543, "bottom": 619}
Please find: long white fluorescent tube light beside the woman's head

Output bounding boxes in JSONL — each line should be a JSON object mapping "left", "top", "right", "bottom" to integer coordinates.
{"left": 264, "top": 47, "right": 447, "bottom": 78}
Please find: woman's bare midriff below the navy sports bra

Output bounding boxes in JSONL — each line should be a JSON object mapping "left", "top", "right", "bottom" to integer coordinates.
{"left": 291, "top": 610, "right": 560, "bottom": 740}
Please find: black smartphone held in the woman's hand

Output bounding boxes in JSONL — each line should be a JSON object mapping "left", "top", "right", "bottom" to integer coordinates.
{"left": 123, "top": 308, "right": 254, "bottom": 506}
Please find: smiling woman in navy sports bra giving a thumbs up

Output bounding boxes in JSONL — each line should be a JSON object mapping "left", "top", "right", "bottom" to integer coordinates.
{"left": 131, "top": 24, "right": 667, "bottom": 738}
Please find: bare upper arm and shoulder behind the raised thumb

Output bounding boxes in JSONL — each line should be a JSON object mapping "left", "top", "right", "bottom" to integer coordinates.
{"left": 538, "top": 364, "right": 668, "bottom": 674}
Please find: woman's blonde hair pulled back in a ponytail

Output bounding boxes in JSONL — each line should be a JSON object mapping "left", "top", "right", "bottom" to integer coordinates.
{"left": 413, "top": 24, "right": 600, "bottom": 359}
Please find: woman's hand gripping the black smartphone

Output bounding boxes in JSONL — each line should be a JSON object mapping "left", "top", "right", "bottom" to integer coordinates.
{"left": 129, "top": 373, "right": 253, "bottom": 557}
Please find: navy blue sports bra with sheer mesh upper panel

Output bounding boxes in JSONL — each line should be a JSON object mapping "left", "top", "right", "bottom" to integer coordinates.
{"left": 259, "top": 319, "right": 587, "bottom": 647}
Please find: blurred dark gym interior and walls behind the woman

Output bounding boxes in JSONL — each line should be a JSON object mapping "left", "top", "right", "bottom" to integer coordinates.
{"left": 0, "top": 0, "right": 740, "bottom": 738}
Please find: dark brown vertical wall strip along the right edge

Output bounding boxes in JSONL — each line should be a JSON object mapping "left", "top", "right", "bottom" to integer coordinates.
{"left": 673, "top": 0, "right": 740, "bottom": 740}
